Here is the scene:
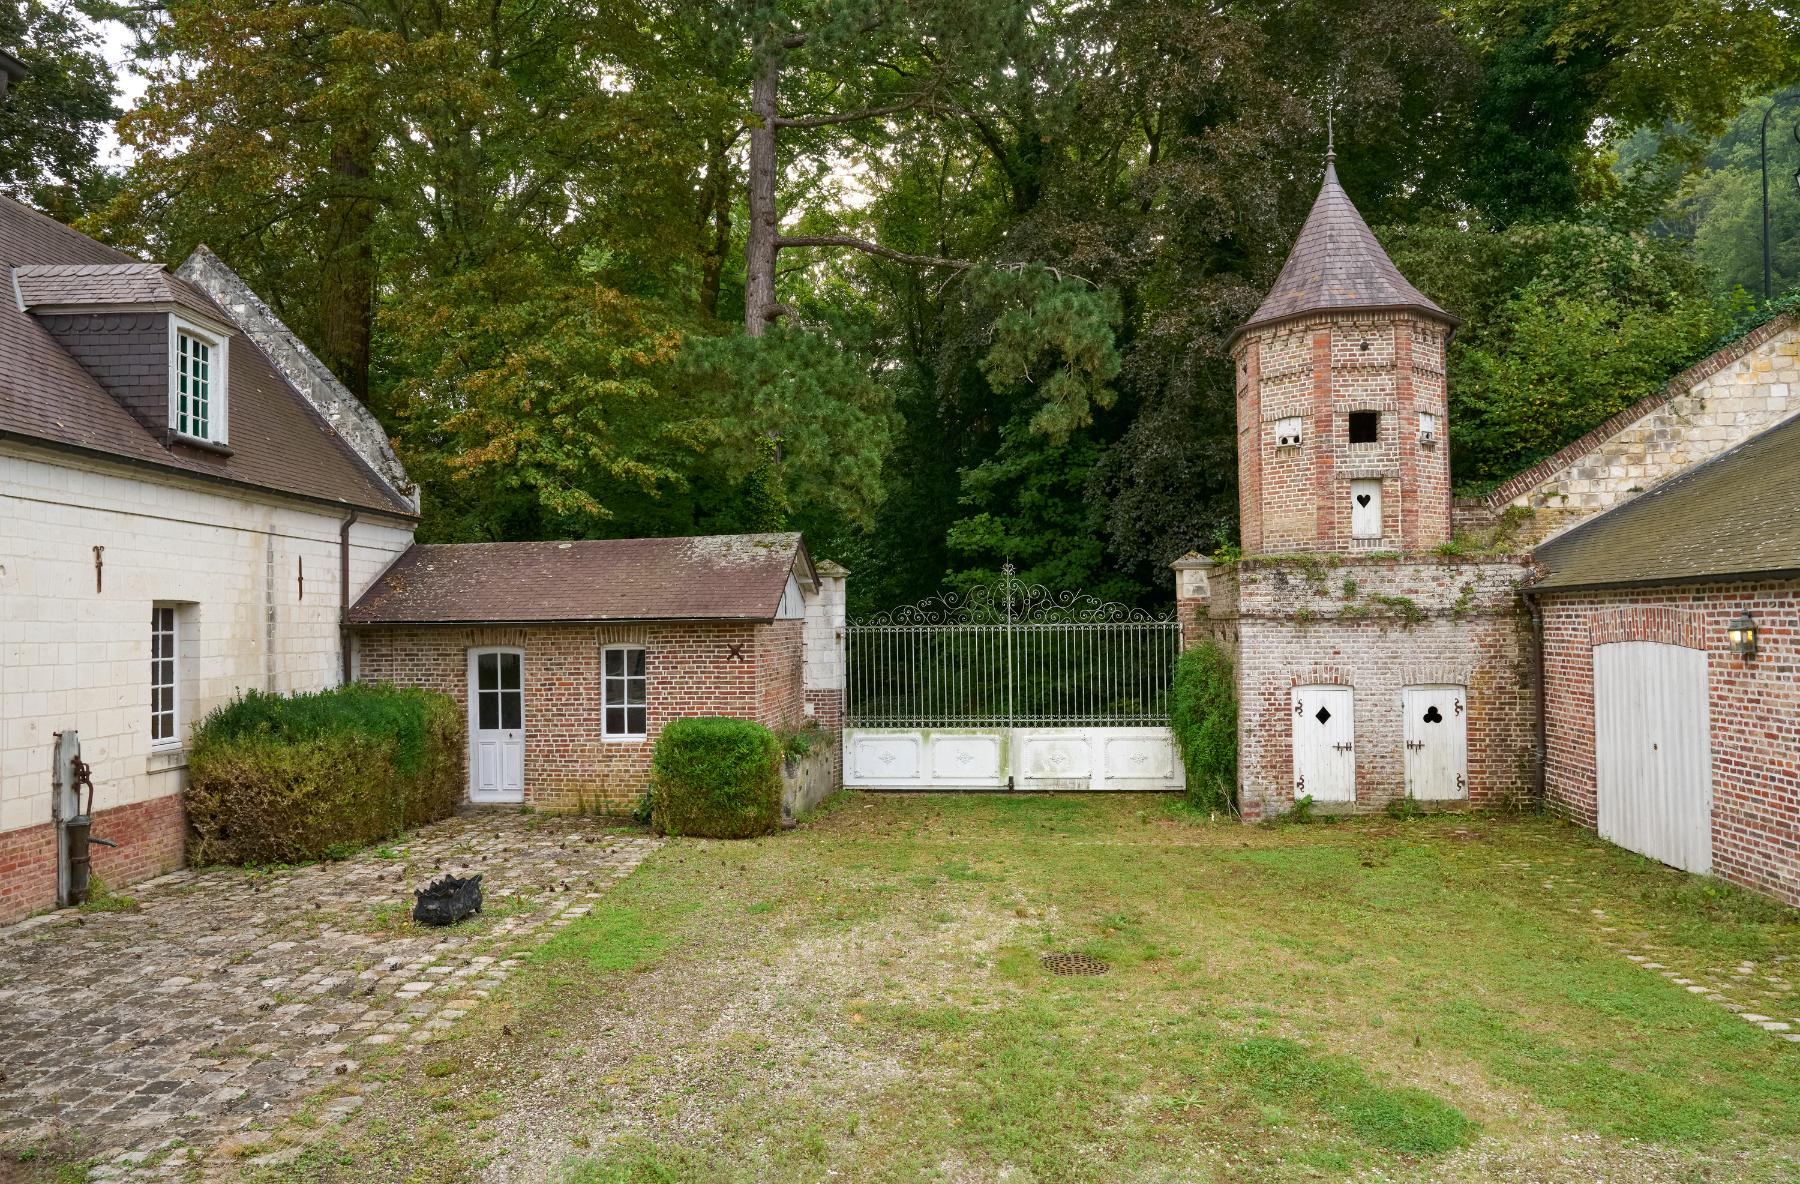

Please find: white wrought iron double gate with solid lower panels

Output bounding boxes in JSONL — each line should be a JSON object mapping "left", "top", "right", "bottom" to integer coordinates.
{"left": 844, "top": 565, "right": 1184, "bottom": 790}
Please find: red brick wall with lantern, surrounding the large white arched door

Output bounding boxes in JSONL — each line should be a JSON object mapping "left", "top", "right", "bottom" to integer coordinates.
{"left": 1544, "top": 579, "right": 1800, "bottom": 905}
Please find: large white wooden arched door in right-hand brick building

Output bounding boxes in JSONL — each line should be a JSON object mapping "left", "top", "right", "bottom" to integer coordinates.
{"left": 1593, "top": 641, "right": 1712, "bottom": 873}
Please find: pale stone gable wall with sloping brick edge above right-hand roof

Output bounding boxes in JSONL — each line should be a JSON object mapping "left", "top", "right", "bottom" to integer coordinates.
{"left": 1487, "top": 317, "right": 1800, "bottom": 545}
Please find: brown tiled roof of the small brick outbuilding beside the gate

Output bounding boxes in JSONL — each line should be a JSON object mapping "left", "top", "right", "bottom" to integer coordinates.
{"left": 349, "top": 534, "right": 815, "bottom": 624}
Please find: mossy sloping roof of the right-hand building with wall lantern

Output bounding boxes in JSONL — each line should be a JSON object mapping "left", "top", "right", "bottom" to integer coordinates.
{"left": 1534, "top": 416, "right": 1800, "bottom": 592}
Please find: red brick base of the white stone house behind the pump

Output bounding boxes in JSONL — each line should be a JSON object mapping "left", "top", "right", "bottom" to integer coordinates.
{"left": 0, "top": 794, "right": 187, "bottom": 923}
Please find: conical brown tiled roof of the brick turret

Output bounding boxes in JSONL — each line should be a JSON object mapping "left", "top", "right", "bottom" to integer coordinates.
{"left": 1231, "top": 157, "right": 1458, "bottom": 340}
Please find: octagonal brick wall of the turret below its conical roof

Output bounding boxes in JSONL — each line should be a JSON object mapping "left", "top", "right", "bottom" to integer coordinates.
{"left": 1237, "top": 313, "right": 1451, "bottom": 554}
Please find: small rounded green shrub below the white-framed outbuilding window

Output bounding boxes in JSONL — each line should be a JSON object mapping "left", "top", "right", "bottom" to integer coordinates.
{"left": 650, "top": 718, "right": 781, "bottom": 839}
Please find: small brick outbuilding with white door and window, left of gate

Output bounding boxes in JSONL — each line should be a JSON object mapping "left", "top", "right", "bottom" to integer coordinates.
{"left": 349, "top": 534, "right": 844, "bottom": 813}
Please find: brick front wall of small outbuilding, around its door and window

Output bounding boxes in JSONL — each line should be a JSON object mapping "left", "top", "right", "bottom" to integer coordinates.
{"left": 356, "top": 619, "right": 806, "bottom": 813}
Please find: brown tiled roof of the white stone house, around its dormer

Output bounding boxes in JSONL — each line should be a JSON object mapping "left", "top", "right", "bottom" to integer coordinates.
{"left": 0, "top": 198, "right": 412, "bottom": 516}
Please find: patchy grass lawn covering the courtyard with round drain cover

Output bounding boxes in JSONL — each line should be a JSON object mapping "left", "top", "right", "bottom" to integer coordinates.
{"left": 250, "top": 795, "right": 1800, "bottom": 1184}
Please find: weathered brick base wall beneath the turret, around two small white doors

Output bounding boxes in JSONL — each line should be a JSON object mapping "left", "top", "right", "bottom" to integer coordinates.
{"left": 1195, "top": 556, "right": 1535, "bottom": 821}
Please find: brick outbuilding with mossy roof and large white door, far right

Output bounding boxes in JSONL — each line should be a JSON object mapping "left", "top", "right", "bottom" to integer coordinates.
{"left": 1530, "top": 417, "right": 1800, "bottom": 905}
